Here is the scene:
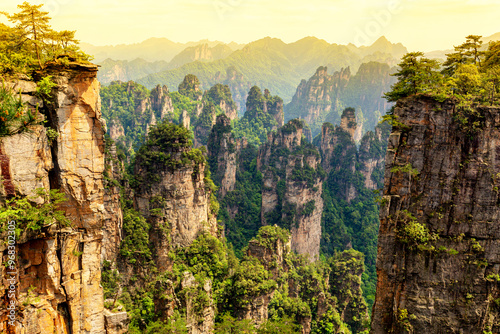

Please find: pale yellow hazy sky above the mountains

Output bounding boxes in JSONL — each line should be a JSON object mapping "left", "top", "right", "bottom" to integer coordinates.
{"left": 0, "top": 0, "right": 500, "bottom": 51}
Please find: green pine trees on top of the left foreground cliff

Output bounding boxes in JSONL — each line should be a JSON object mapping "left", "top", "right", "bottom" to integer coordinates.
{"left": 0, "top": 2, "right": 91, "bottom": 75}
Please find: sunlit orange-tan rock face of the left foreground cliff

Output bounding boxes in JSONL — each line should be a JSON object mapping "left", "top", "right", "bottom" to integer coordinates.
{"left": 0, "top": 64, "right": 109, "bottom": 334}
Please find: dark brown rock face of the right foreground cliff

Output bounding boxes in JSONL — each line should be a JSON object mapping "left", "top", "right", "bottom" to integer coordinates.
{"left": 371, "top": 96, "right": 500, "bottom": 334}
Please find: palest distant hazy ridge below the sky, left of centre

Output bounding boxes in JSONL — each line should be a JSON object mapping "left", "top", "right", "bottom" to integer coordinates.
{"left": 80, "top": 38, "right": 243, "bottom": 63}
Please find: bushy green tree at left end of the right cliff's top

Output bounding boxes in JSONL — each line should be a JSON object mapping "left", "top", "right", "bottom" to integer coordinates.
{"left": 384, "top": 52, "right": 439, "bottom": 102}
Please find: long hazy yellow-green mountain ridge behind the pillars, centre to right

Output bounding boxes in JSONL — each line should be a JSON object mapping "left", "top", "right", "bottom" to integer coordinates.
{"left": 137, "top": 37, "right": 407, "bottom": 108}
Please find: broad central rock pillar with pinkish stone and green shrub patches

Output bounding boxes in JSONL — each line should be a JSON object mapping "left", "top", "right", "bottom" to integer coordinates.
{"left": 257, "top": 120, "right": 324, "bottom": 260}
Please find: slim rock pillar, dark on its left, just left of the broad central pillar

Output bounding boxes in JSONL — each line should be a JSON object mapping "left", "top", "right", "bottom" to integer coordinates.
{"left": 207, "top": 115, "right": 242, "bottom": 199}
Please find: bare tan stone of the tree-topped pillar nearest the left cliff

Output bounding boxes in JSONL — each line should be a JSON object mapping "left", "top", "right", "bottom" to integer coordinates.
{"left": 134, "top": 152, "right": 217, "bottom": 271}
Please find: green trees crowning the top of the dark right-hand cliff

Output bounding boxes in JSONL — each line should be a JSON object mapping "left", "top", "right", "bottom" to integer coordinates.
{"left": 385, "top": 35, "right": 500, "bottom": 108}
